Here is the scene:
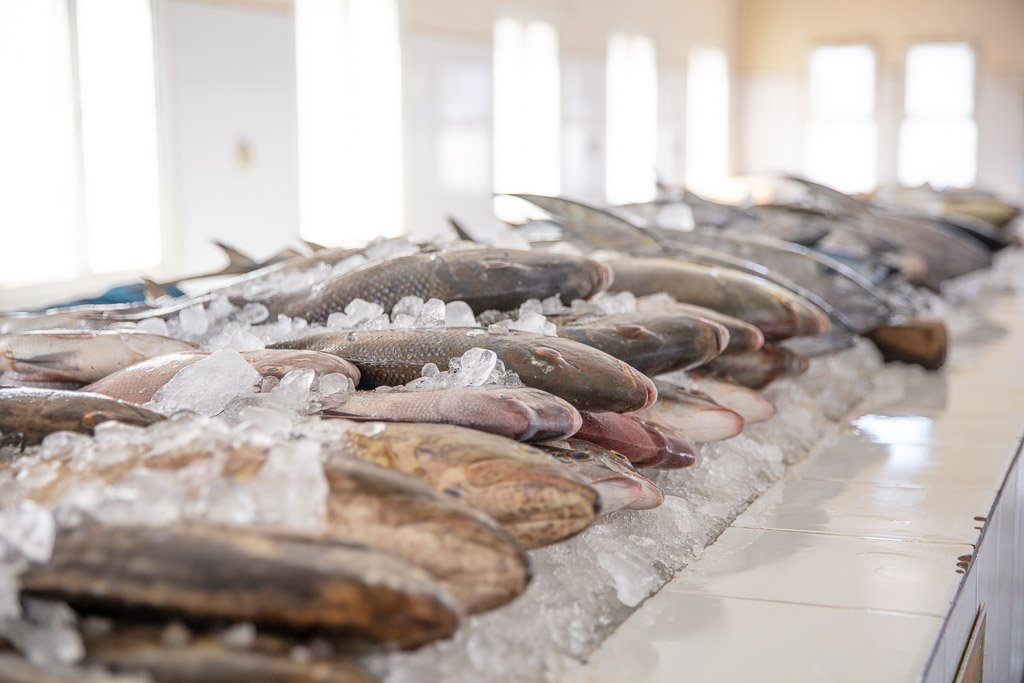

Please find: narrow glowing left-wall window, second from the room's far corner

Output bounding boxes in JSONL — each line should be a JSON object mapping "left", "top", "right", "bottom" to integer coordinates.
{"left": 604, "top": 34, "right": 657, "bottom": 204}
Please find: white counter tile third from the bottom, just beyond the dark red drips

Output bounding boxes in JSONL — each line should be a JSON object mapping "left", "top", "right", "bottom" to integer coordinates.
{"left": 733, "top": 478, "right": 995, "bottom": 544}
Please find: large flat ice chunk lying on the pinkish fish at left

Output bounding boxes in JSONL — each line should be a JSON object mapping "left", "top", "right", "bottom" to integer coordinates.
{"left": 153, "top": 349, "right": 261, "bottom": 417}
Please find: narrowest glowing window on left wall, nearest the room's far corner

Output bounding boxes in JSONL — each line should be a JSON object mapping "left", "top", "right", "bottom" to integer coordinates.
{"left": 686, "top": 47, "right": 729, "bottom": 194}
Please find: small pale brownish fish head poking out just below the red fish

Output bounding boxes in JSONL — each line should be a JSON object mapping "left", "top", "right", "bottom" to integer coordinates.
{"left": 541, "top": 438, "right": 665, "bottom": 515}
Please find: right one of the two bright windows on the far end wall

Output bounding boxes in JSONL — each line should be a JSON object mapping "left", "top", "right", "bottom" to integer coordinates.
{"left": 898, "top": 43, "right": 978, "bottom": 187}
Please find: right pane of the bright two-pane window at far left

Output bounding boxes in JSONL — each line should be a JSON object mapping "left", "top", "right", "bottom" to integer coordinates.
{"left": 76, "top": 0, "right": 161, "bottom": 272}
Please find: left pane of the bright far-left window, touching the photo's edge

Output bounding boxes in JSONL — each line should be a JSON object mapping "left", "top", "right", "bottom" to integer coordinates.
{"left": 0, "top": 0, "right": 82, "bottom": 286}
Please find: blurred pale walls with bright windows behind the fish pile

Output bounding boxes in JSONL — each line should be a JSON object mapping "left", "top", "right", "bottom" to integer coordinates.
{"left": 0, "top": 0, "right": 1024, "bottom": 307}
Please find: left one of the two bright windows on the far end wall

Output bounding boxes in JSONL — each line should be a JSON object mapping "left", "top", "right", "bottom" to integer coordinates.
{"left": 804, "top": 45, "right": 878, "bottom": 193}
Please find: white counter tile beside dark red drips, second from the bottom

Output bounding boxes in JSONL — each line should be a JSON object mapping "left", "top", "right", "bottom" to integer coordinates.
{"left": 663, "top": 527, "right": 973, "bottom": 617}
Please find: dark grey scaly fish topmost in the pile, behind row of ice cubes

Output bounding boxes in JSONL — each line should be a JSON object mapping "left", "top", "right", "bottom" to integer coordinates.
{"left": 263, "top": 249, "right": 611, "bottom": 323}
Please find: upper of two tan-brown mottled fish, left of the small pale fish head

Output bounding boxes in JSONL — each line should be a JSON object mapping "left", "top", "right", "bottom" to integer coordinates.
{"left": 326, "top": 423, "right": 600, "bottom": 549}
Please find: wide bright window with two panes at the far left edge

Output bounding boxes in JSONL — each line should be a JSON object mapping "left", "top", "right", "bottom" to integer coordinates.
{"left": 0, "top": 0, "right": 161, "bottom": 285}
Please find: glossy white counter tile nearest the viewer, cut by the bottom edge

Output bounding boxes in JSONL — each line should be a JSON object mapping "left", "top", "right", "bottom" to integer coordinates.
{"left": 586, "top": 591, "right": 942, "bottom": 683}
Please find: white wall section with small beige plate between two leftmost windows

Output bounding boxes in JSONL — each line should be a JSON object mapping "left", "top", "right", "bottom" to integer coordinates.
{"left": 158, "top": 0, "right": 299, "bottom": 272}
